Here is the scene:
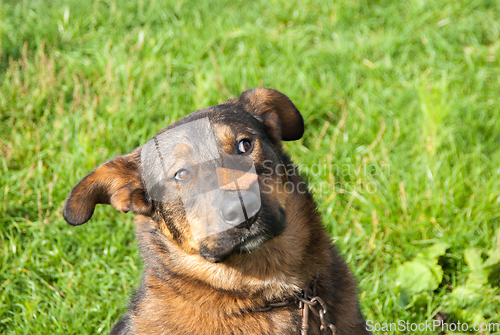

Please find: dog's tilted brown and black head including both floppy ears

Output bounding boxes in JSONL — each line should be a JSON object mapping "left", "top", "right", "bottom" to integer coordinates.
{"left": 63, "top": 88, "right": 304, "bottom": 262}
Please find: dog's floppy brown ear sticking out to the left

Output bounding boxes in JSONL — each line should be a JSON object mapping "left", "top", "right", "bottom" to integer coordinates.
{"left": 63, "top": 150, "right": 152, "bottom": 226}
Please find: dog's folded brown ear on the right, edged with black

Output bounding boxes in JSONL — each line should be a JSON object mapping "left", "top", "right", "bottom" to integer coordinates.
{"left": 237, "top": 88, "right": 304, "bottom": 143}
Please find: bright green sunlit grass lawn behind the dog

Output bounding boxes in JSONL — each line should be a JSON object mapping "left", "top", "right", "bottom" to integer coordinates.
{"left": 0, "top": 0, "right": 500, "bottom": 334}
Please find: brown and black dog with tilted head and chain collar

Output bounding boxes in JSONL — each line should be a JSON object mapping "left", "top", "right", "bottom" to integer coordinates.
{"left": 63, "top": 88, "right": 370, "bottom": 335}
